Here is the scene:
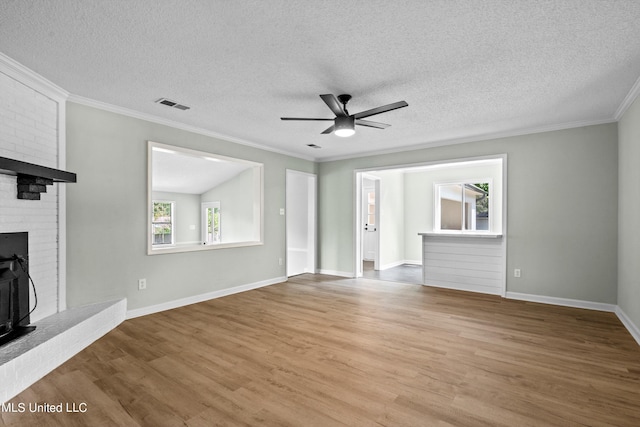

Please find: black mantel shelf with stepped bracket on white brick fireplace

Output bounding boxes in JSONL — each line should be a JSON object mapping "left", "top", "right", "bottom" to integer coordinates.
{"left": 0, "top": 157, "right": 76, "bottom": 200}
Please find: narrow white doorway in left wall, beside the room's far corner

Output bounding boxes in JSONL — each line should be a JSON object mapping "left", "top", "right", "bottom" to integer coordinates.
{"left": 285, "top": 170, "right": 317, "bottom": 277}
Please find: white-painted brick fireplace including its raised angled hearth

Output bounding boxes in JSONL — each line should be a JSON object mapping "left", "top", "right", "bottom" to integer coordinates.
{"left": 0, "top": 53, "right": 126, "bottom": 402}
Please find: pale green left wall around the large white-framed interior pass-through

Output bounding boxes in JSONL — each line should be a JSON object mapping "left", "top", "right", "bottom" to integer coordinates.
{"left": 66, "top": 102, "right": 316, "bottom": 310}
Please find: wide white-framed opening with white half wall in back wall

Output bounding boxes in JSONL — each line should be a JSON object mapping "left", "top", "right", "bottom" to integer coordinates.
{"left": 353, "top": 154, "right": 507, "bottom": 295}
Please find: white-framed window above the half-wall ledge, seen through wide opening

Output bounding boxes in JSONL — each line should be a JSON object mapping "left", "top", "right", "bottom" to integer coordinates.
{"left": 434, "top": 181, "right": 491, "bottom": 232}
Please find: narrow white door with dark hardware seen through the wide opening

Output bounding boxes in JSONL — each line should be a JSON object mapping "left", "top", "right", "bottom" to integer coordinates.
{"left": 361, "top": 178, "right": 380, "bottom": 270}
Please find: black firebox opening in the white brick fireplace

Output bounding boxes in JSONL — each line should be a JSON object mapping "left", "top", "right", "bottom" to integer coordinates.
{"left": 0, "top": 232, "right": 35, "bottom": 345}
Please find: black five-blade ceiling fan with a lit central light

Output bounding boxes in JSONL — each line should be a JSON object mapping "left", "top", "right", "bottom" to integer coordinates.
{"left": 281, "top": 94, "right": 409, "bottom": 136}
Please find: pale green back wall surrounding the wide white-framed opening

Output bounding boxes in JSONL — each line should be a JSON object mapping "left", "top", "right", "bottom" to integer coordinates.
{"left": 318, "top": 123, "right": 618, "bottom": 304}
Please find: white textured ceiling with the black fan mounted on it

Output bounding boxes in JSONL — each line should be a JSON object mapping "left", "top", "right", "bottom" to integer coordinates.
{"left": 0, "top": 0, "right": 640, "bottom": 160}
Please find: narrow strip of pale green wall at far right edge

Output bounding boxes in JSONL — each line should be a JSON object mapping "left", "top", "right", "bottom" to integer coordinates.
{"left": 618, "top": 98, "right": 640, "bottom": 328}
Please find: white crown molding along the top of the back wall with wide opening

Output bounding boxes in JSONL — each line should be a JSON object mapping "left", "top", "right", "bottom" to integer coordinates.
{"left": 316, "top": 118, "right": 617, "bottom": 163}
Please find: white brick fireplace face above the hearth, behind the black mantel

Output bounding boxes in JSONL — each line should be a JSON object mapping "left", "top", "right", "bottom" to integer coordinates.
{"left": 0, "top": 57, "right": 65, "bottom": 322}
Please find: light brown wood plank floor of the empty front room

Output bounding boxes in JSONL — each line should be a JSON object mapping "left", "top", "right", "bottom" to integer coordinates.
{"left": 0, "top": 275, "right": 640, "bottom": 427}
